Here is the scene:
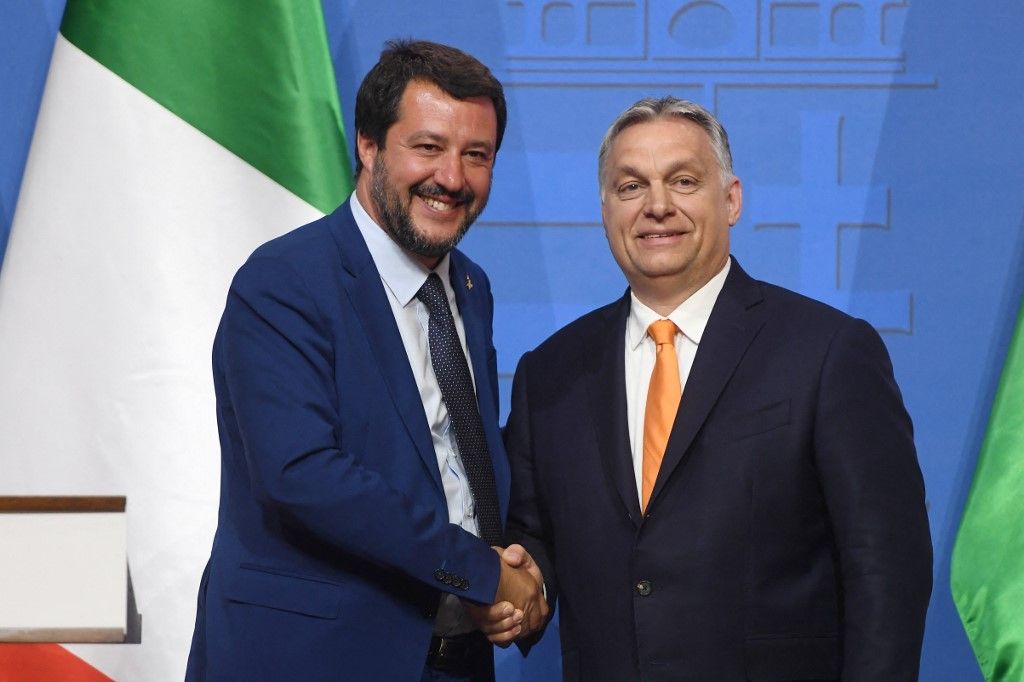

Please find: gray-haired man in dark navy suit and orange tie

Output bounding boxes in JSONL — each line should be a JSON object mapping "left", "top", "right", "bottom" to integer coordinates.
{"left": 506, "top": 97, "right": 932, "bottom": 682}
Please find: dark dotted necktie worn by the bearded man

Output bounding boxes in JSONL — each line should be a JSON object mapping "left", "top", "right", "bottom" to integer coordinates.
{"left": 416, "top": 272, "right": 503, "bottom": 545}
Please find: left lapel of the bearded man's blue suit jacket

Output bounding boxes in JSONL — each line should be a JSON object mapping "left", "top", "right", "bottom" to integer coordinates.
{"left": 328, "top": 202, "right": 444, "bottom": 495}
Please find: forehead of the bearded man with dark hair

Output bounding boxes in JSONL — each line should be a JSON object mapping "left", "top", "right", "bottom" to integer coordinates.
{"left": 392, "top": 81, "right": 498, "bottom": 143}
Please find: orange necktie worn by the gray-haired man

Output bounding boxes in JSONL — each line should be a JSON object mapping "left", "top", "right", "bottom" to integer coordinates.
{"left": 640, "top": 319, "right": 683, "bottom": 511}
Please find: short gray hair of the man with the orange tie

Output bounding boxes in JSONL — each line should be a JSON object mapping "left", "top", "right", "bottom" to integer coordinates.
{"left": 597, "top": 95, "right": 733, "bottom": 193}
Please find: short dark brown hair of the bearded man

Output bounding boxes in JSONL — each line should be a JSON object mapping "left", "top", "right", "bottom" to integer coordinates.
{"left": 355, "top": 40, "right": 508, "bottom": 175}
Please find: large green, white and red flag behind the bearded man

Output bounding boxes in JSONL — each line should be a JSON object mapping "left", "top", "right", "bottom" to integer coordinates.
{"left": 0, "top": 0, "right": 351, "bottom": 681}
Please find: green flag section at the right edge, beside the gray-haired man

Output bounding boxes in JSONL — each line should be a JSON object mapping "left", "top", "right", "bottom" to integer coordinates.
{"left": 950, "top": 296, "right": 1024, "bottom": 682}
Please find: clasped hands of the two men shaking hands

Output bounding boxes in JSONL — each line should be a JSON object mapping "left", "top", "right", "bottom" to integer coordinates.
{"left": 462, "top": 545, "right": 549, "bottom": 647}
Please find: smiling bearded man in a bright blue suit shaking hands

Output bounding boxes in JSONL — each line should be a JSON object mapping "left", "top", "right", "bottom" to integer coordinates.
{"left": 186, "top": 42, "right": 547, "bottom": 681}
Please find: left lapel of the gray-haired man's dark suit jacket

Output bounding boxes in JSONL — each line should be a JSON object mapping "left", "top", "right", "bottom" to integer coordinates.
{"left": 584, "top": 292, "right": 641, "bottom": 525}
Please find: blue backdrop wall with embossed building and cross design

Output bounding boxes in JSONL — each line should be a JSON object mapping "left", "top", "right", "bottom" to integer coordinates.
{"left": 0, "top": 0, "right": 1024, "bottom": 681}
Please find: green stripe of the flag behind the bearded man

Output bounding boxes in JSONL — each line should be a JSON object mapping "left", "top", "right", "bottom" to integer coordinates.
{"left": 60, "top": 0, "right": 352, "bottom": 213}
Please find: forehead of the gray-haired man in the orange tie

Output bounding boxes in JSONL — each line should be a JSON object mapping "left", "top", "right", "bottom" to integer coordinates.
{"left": 608, "top": 117, "right": 717, "bottom": 167}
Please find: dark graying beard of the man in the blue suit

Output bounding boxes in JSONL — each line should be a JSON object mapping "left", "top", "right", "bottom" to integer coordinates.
{"left": 370, "top": 155, "right": 486, "bottom": 258}
